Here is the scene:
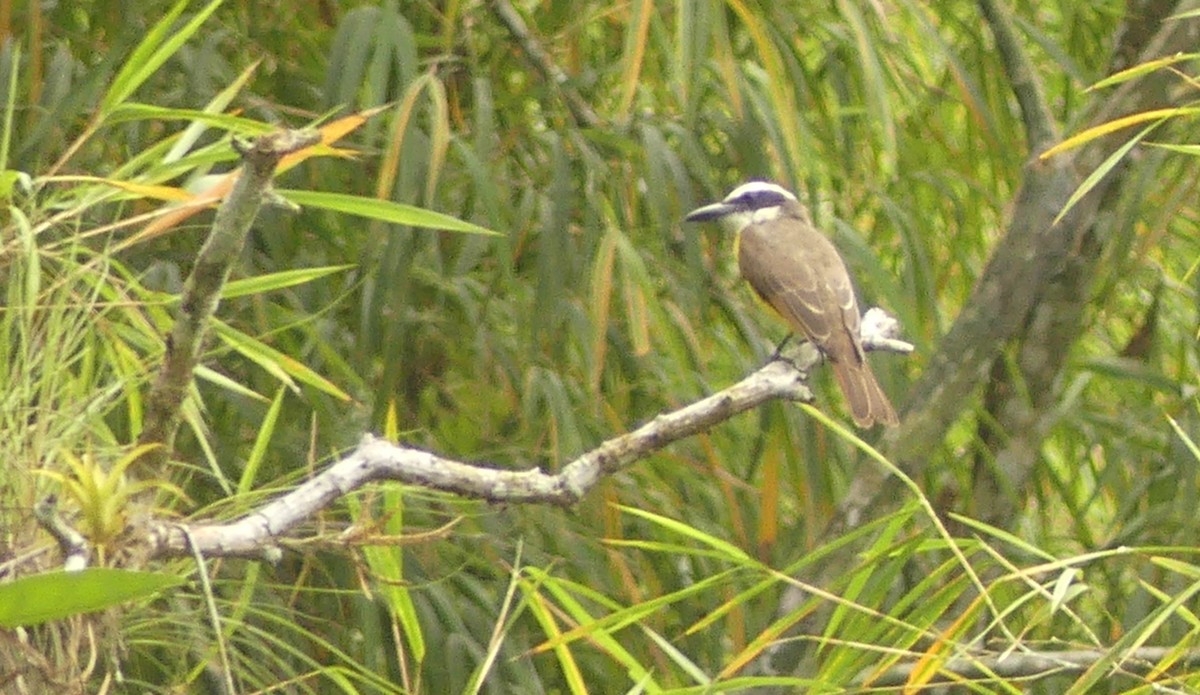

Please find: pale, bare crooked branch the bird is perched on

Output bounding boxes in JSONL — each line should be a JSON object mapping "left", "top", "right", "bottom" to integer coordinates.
{"left": 140, "top": 324, "right": 912, "bottom": 557}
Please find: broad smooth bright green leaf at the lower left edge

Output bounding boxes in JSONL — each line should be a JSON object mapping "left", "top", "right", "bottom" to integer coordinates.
{"left": 0, "top": 568, "right": 185, "bottom": 628}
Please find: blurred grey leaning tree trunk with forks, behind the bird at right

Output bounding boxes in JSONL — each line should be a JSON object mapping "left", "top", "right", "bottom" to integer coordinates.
{"left": 836, "top": 0, "right": 1200, "bottom": 526}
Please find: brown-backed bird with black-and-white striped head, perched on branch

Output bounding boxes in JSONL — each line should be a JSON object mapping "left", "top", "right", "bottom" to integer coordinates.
{"left": 684, "top": 181, "right": 900, "bottom": 429}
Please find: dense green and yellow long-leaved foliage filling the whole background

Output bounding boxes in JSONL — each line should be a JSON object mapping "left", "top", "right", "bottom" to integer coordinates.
{"left": 0, "top": 0, "right": 1200, "bottom": 694}
